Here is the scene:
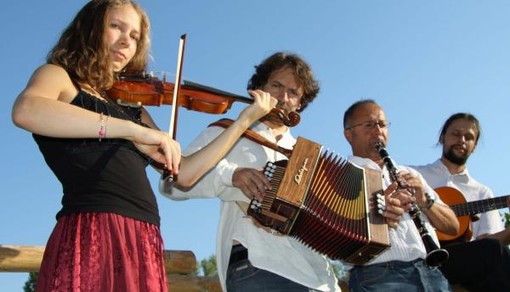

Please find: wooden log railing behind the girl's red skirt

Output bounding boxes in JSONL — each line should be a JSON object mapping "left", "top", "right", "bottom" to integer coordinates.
{"left": 0, "top": 245, "right": 221, "bottom": 292}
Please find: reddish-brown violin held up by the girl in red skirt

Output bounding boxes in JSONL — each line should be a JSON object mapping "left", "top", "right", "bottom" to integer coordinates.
{"left": 106, "top": 73, "right": 301, "bottom": 127}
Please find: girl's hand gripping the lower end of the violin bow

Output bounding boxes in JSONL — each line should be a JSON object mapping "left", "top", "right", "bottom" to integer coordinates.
{"left": 133, "top": 126, "right": 181, "bottom": 174}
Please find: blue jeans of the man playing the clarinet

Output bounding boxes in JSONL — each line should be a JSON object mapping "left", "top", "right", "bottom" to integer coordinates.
{"left": 349, "top": 259, "right": 451, "bottom": 292}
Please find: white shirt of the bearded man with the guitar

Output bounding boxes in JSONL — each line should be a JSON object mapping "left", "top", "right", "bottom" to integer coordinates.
{"left": 413, "top": 159, "right": 505, "bottom": 240}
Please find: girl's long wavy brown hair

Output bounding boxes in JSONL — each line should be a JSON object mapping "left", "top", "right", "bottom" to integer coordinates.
{"left": 46, "top": 0, "right": 150, "bottom": 90}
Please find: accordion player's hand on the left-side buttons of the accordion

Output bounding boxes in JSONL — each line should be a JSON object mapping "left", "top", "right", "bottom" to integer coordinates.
{"left": 232, "top": 167, "right": 271, "bottom": 202}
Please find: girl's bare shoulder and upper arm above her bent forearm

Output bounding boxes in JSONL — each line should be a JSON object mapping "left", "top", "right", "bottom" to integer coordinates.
{"left": 21, "top": 64, "right": 78, "bottom": 102}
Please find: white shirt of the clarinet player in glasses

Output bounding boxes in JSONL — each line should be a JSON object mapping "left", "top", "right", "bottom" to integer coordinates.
{"left": 349, "top": 156, "right": 444, "bottom": 265}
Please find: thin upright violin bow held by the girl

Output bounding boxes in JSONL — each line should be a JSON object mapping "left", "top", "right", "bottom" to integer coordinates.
{"left": 161, "top": 34, "right": 186, "bottom": 182}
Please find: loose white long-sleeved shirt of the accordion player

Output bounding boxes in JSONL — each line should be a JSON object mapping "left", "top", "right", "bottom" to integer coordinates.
{"left": 163, "top": 123, "right": 340, "bottom": 291}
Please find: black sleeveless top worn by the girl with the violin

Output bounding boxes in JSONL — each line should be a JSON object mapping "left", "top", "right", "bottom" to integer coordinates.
{"left": 33, "top": 91, "right": 160, "bottom": 226}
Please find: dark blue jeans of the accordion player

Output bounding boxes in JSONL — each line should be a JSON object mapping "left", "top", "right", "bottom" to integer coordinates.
{"left": 227, "top": 259, "right": 316, "bottom": 292}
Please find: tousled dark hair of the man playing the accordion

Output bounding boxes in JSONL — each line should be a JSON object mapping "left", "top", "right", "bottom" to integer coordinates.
{"left": 247, "top": 52, "right": 320, "bottom": 112}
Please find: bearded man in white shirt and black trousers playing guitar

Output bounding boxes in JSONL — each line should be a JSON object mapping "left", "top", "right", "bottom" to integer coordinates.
{"left": 413, "top": 113, "right": 510, "bottom": 291}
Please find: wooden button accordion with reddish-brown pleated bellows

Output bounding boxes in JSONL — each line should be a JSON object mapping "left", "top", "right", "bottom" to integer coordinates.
{"left": 247, "top": 137, "right": 390, "bottom": 264}
